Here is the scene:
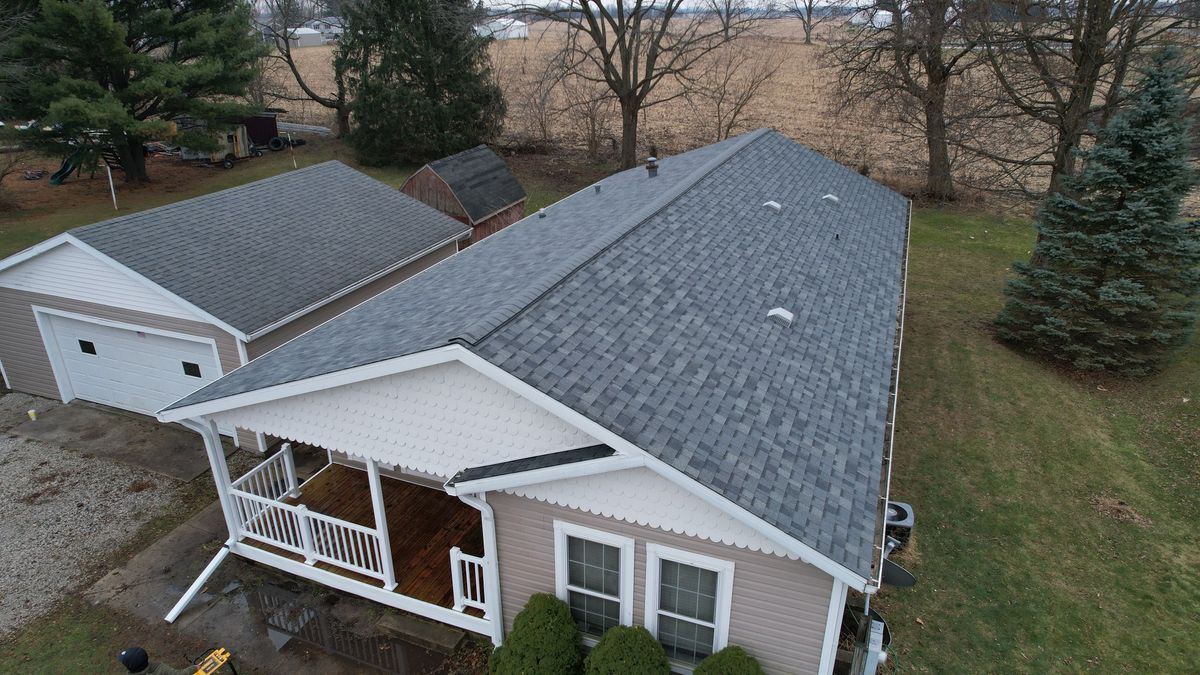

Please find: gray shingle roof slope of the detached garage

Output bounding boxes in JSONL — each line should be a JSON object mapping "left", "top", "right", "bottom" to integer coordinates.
{"left": 71, "top": 161, "right": 470, "bottom": 334}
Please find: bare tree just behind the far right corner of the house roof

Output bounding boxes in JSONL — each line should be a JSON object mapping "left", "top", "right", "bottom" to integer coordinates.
{"left": 829, "top": 0, "right": 976, "bottom": 199}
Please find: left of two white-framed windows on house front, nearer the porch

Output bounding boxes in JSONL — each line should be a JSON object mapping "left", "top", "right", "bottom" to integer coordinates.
{"left": 554, "top": 520, "right": 634, "bottom": 638}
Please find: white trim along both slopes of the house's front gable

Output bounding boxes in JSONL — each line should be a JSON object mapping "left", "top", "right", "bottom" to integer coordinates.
{"left": 158, "top": 345, "right": 871, "bottom": 592}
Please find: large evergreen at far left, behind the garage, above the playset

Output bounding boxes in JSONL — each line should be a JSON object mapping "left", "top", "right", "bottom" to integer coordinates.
{"left": 6, "top": 0, "right": 265, "bottom": 181}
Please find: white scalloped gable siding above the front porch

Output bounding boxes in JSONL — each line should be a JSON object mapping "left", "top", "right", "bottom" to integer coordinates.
{"left": 211, "top": 362, "right": 596, "bottom": 479}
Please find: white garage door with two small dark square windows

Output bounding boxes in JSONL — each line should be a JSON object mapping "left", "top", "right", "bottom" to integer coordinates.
{"left": 42, "top": 315, "right": 221, "bottom": 414}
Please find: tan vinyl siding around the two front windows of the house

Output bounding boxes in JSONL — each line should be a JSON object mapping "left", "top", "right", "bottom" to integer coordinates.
{"left": 487, "top": 492, "right": 833, "bottom": 673}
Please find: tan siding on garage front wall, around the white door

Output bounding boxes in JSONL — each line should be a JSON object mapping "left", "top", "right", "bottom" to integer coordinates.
{"left": 0, "top": 288, "right": 241, "bottom": 399}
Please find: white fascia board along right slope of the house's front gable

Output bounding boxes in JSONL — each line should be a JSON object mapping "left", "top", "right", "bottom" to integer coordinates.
{"left": 456, "top": 345, "right": 869, "bottom": 591}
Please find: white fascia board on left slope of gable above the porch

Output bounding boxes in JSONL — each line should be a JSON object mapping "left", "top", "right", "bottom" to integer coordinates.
{"left": 157, "top": 346, "right": 457, "bottom": 422}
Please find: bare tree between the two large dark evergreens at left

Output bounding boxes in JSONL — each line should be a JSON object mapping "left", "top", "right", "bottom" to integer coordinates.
{"left": 257, "top": 0, "right": 350, "bottom": 138}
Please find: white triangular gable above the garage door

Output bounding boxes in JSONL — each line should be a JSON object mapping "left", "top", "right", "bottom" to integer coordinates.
{"left": 0, "top": 238, "right": 208, "bottom": 323}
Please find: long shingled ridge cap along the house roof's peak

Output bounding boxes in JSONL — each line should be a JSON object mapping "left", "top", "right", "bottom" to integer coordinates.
{"left": 449, "top": 129, "right": 770, "bottom": 345}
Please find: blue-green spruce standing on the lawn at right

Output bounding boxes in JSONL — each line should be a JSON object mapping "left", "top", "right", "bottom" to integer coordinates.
{"left": 996, "top": 49, "right": 1200, "bottom": 375}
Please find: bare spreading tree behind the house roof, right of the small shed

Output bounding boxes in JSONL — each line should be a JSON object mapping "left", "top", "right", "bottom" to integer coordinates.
{"left": 515, "top": 0, "right": 757, "bottom": 168}
